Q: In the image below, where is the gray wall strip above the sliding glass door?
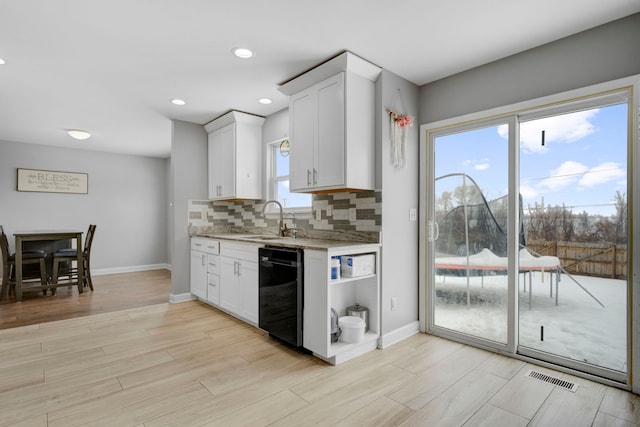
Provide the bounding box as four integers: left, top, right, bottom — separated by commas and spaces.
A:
420, 14, 640, 124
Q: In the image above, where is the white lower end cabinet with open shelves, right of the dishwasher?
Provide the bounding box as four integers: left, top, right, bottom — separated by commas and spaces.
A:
303, 245, 380, 364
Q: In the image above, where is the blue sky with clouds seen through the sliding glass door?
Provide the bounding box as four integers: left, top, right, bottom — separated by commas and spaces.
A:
435, 104, 627, 215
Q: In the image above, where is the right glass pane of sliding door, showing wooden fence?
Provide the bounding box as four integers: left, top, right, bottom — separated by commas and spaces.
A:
519, 103, 629, 380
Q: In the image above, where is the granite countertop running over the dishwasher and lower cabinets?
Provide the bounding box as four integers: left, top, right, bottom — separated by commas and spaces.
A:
194, 233, 380, 250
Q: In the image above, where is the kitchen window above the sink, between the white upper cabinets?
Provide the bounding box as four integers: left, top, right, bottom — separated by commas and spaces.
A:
267, 138, 311, 213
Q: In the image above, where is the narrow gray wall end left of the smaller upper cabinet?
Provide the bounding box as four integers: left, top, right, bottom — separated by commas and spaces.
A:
167, 120, 208, 301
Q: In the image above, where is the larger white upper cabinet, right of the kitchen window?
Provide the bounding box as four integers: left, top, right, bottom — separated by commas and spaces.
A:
280, 52, 380, 193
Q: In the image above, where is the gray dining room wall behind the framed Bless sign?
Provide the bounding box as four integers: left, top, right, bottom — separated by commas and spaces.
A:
0, 141, 167, 274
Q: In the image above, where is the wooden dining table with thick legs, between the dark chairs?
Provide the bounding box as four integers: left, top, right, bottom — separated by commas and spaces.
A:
13, 230, 84, 301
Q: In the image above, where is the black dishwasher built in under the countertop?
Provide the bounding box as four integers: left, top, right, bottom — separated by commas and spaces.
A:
258, 246, 303, 347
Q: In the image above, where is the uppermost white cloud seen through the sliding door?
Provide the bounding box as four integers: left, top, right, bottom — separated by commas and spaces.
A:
498, 109, 600, 153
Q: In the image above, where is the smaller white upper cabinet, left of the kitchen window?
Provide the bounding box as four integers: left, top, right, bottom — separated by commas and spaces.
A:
205, 111, 264, 200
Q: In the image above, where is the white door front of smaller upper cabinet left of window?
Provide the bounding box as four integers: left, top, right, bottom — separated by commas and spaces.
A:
208, 123, 235, 200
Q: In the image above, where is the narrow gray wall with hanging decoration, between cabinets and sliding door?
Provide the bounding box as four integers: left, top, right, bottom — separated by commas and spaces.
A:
376, 70, 420, 341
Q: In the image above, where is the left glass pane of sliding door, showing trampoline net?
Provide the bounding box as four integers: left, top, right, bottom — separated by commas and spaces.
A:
427, 123, 509, 345
